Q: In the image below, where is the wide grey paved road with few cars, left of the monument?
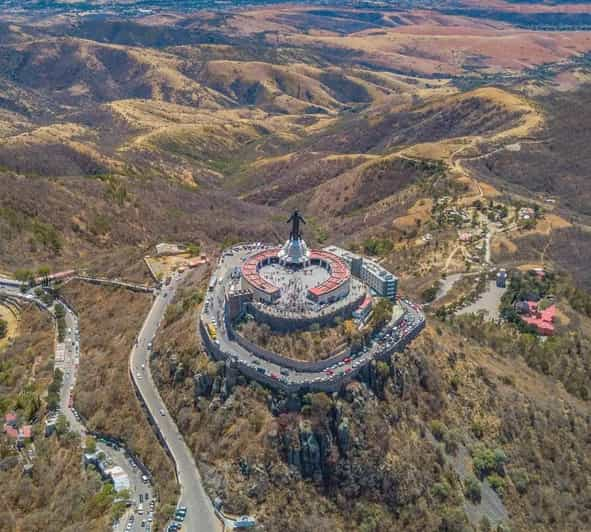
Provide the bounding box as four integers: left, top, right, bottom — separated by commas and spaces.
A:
130, 276, 221, 532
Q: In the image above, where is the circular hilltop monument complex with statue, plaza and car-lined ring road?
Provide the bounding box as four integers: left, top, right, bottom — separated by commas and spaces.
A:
200, 210, 425, 391
